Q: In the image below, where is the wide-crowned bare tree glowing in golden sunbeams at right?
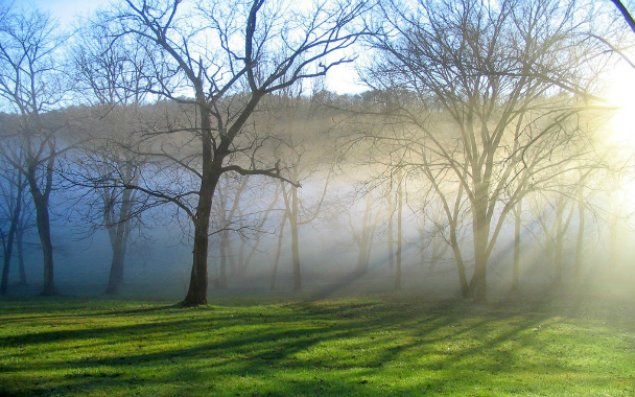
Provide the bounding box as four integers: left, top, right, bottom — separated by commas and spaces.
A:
370, 0, 600, 301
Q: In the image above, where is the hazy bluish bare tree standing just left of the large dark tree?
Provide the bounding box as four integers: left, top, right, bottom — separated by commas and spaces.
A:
71, 19, 152, 294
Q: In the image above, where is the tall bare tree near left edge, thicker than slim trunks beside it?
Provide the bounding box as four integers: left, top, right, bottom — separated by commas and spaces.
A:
0, 10, 65, 295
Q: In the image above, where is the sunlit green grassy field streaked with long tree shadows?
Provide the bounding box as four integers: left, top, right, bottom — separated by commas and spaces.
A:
0, 297, 635, 397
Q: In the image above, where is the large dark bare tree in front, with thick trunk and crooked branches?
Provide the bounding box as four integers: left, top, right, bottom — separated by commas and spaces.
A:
104, 0, 365, 305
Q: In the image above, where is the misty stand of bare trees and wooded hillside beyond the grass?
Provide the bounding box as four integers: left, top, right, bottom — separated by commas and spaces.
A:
0, 0, 635, 305
